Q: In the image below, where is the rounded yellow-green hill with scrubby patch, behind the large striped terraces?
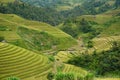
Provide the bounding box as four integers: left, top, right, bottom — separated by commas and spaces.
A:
0, 14, 76, 51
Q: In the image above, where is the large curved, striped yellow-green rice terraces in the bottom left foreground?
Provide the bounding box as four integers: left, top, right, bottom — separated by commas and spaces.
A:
0, 43, 52, 80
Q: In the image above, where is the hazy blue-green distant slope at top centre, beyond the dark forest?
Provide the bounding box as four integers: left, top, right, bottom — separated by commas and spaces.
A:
22, 0, 83, 10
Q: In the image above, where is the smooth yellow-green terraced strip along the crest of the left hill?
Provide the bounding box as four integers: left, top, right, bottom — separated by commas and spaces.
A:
0, 14, 70, 37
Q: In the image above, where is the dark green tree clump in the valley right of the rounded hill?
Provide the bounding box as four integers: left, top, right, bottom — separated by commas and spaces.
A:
60, 18, 100, 42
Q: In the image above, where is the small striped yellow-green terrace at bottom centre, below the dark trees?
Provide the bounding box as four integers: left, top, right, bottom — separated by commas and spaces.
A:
63, 64, 87, 76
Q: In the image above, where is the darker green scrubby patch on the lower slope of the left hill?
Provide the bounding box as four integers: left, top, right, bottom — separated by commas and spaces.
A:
18, 27, 76, 51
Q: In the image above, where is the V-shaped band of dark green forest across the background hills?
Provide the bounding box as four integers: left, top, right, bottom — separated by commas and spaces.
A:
0, 0, 120, 26
